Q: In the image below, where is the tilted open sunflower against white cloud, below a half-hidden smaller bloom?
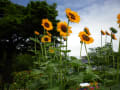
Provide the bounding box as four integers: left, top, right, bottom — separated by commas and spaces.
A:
78, 31, 94, 44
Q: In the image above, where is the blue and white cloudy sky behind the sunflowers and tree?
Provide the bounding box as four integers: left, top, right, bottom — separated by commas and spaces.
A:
11, 0, 120, 57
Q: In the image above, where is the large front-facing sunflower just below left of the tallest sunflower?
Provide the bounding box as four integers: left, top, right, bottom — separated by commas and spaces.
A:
57, 22, 72, 36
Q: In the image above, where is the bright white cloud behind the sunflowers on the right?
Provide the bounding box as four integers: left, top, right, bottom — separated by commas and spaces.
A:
61, 0, 120, 56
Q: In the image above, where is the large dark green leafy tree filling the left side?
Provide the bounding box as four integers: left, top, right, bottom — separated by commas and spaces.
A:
0, 0, 59, 84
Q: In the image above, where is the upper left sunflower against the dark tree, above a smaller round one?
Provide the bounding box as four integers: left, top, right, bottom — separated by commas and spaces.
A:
41, 19, 53, 31
